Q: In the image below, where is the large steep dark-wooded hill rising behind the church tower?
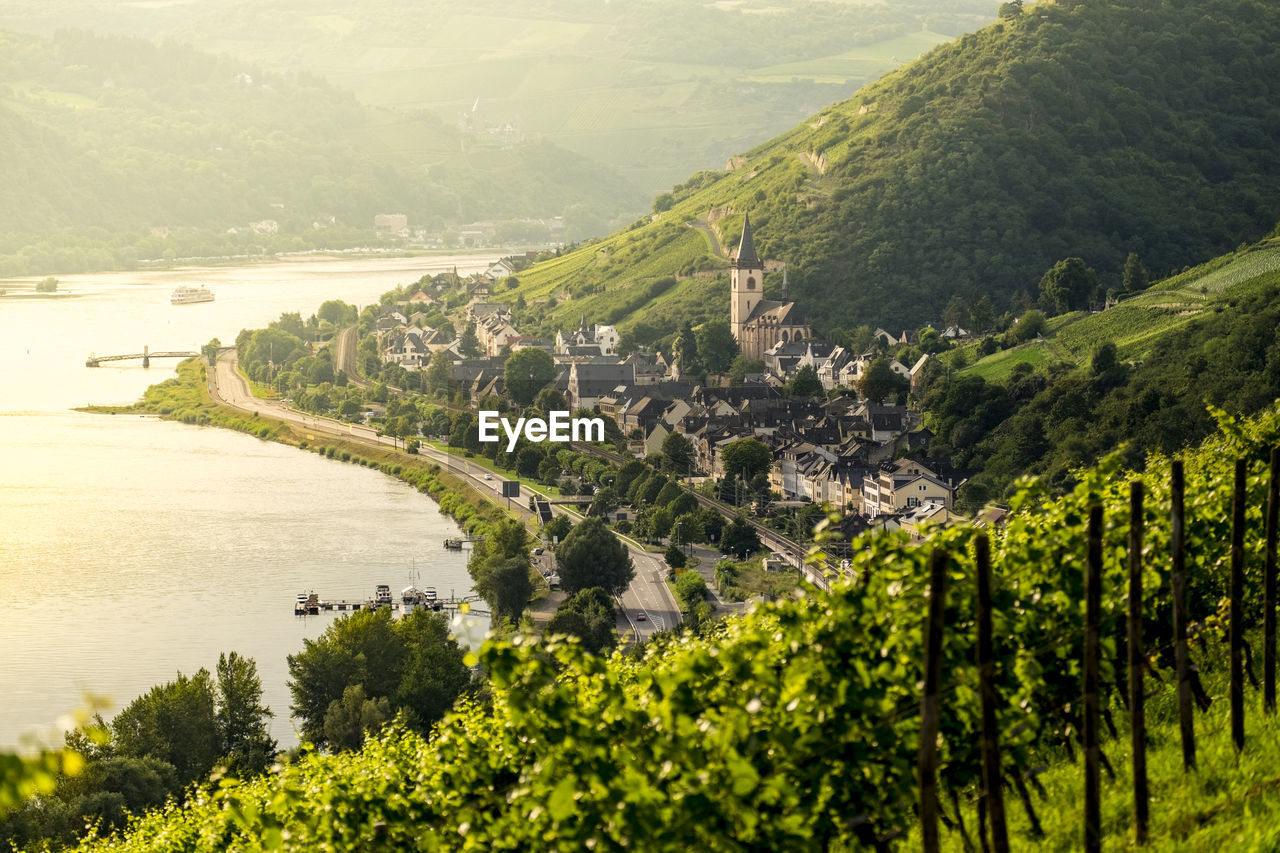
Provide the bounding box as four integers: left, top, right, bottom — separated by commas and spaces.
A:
499, 0, 1280, 333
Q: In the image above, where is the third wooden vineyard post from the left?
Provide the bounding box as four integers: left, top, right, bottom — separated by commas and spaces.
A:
1082, 506, 1102, 853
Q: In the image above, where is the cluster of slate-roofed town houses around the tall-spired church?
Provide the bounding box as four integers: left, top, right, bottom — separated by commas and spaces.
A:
370, 218, 983, 543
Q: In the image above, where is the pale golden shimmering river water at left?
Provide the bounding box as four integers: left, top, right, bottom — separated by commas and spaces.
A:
0, 255, 493, 747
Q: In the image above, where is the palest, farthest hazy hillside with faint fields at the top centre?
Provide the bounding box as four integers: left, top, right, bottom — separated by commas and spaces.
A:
0, 0, 996, 192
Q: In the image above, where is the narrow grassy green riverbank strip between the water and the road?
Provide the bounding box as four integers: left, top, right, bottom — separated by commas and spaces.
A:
77, 359, 507, 535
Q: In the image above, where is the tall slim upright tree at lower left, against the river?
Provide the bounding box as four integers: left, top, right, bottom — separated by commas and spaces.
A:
216, 652, 275, 779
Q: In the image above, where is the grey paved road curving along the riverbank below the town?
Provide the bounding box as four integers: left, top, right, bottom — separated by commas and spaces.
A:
209, 345, 680, 642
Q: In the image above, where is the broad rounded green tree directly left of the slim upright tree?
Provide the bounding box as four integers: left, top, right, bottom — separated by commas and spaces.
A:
111, 669, 223, 783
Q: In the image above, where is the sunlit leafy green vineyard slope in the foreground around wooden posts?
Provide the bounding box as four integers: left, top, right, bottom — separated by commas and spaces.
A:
45, 402, 1280, 853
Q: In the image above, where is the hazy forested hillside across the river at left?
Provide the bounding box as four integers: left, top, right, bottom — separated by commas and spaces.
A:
0, 31, 644, 274
